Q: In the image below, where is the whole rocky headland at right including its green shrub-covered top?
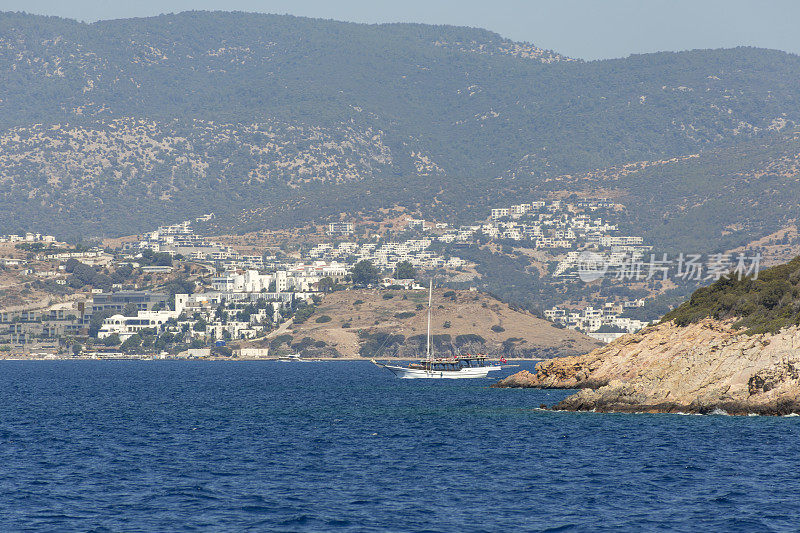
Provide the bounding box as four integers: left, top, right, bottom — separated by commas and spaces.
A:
493, 259, 800, 415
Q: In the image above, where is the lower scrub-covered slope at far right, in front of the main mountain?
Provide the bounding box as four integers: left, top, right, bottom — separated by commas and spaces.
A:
510, 132, 800, 252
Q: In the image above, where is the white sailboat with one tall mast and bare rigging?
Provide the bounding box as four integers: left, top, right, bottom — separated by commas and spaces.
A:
372, 279, 503, 379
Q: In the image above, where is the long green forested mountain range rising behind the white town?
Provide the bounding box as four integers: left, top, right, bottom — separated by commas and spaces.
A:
0, 12, 800, 248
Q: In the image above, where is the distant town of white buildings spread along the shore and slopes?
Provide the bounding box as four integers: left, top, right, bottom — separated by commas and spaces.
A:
0, 199, 650, 357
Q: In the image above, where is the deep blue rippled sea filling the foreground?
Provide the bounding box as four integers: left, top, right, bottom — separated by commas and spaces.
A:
0, 361, 800, 532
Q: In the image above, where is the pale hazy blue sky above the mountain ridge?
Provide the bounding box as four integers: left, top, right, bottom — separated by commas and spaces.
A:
6, 0, 800, 59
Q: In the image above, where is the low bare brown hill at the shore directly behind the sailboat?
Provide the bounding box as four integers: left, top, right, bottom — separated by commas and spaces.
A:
256, 289, 599, 359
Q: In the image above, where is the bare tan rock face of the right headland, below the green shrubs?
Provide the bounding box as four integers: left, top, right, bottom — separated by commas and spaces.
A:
494, 319, 800, 415
